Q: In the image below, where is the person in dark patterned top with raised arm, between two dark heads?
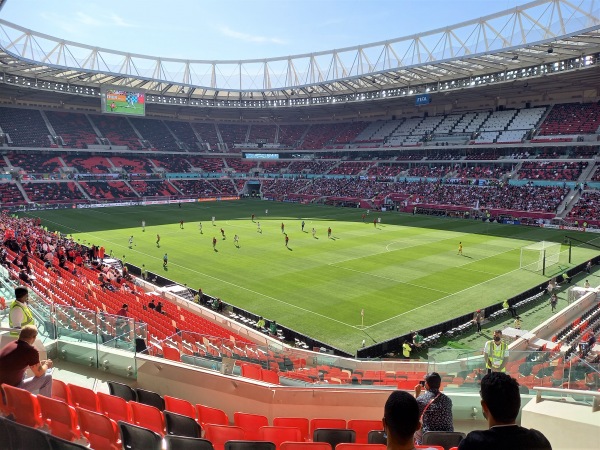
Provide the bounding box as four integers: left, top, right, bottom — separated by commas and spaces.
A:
415, 372, 454, 445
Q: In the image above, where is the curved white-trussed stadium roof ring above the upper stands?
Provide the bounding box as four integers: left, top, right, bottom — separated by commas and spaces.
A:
0, 0, 600, 115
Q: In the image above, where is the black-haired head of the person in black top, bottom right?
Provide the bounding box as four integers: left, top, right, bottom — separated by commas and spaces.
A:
480, 372, 521, 426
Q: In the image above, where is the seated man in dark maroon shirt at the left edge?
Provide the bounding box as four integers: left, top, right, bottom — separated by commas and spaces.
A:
0, 325, 53, 397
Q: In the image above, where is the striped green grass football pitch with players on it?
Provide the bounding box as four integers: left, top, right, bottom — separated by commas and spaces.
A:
21, 200, 600, 353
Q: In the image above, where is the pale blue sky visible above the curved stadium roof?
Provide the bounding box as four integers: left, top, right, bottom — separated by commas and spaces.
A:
0, 0, 527, 60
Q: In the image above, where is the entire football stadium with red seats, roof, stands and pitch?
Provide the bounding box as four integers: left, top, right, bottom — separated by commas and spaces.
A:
0, 0, 600, 450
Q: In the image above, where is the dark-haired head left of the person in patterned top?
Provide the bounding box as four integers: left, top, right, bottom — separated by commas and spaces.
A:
382, 391, 420, 444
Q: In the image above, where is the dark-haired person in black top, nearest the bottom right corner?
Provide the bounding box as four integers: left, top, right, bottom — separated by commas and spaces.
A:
458, 372, 552, 450
